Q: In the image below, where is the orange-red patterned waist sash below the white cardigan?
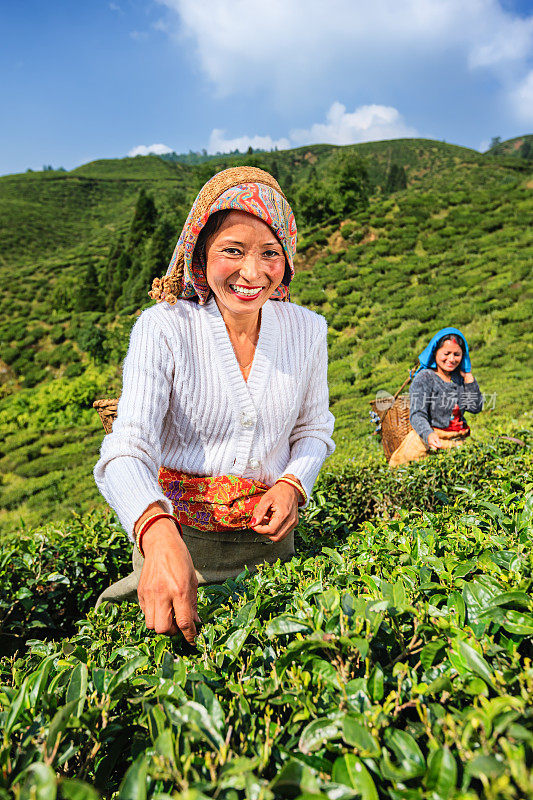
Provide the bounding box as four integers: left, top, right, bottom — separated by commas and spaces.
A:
159, 467, 269, 531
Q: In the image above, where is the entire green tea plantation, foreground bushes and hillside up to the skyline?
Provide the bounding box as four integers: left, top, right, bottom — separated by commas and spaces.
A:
0, 141, 533, 800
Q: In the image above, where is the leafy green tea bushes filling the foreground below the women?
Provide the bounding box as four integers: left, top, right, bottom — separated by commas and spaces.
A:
0, 440, 533, 800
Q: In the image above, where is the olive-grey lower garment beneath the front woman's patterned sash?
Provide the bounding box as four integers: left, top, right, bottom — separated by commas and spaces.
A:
96, 525, 294, 608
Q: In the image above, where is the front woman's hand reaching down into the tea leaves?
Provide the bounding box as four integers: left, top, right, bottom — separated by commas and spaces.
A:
137, 519, 202, 644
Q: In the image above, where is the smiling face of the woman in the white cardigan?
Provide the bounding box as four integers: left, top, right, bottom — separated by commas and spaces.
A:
206, 211, 285, 315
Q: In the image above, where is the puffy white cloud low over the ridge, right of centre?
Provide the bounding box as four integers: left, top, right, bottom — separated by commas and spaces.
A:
291, 102, 418, 146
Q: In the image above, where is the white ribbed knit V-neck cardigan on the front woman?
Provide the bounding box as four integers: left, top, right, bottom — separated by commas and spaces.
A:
94, 297, 335, 538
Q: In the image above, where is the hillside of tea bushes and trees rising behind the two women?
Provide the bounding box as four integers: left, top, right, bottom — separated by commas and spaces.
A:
0, 139, 533, 530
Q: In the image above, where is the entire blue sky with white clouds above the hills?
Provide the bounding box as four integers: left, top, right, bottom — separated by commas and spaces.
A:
0, 0, 533, 174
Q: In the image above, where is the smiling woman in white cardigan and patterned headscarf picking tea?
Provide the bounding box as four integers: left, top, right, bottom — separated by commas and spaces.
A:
91, 167, 334, 641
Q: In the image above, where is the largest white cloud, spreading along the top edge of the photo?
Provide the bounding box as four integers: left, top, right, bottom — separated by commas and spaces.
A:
159, 0, 533, 100
